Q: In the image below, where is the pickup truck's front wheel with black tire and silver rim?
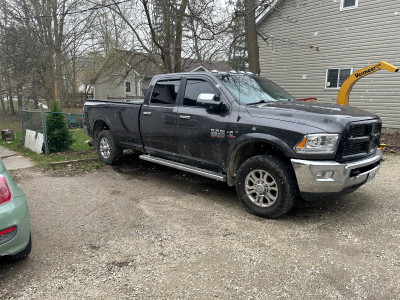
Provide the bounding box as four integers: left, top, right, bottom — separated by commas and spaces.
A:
236, 155, 299, 219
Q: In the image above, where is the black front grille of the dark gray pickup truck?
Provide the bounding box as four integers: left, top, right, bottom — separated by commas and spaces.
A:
338, 120, 382, 161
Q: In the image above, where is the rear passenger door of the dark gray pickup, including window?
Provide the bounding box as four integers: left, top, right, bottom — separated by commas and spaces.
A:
140, 78, 181, 158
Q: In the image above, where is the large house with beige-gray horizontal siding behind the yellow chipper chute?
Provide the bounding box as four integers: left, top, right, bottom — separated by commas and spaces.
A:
257, 0, 400, 128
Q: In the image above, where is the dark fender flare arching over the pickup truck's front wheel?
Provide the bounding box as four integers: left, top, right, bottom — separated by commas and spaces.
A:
227, 133, 295, 186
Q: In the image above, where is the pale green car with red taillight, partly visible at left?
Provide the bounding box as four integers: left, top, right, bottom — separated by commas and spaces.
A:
0, 160, 32, 260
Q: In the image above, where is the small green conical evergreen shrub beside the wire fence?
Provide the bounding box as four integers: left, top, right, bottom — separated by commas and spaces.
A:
46, 101, 74, 153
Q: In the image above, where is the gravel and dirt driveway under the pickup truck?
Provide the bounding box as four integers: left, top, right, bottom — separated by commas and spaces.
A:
0, 154, 400, 299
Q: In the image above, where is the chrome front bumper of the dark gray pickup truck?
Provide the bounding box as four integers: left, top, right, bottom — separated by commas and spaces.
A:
291, 149, 382, 194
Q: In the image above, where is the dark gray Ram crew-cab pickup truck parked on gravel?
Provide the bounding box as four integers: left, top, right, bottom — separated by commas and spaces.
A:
84, 72, 382, 218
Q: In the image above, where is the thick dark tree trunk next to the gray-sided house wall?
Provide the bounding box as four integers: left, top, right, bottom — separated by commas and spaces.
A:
244, 0, 260, 74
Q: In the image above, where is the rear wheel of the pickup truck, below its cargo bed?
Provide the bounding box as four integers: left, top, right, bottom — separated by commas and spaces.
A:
97, 130, 122, 165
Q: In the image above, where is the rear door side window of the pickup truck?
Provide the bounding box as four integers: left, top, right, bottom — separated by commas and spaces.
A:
150, 79, 181, 105
